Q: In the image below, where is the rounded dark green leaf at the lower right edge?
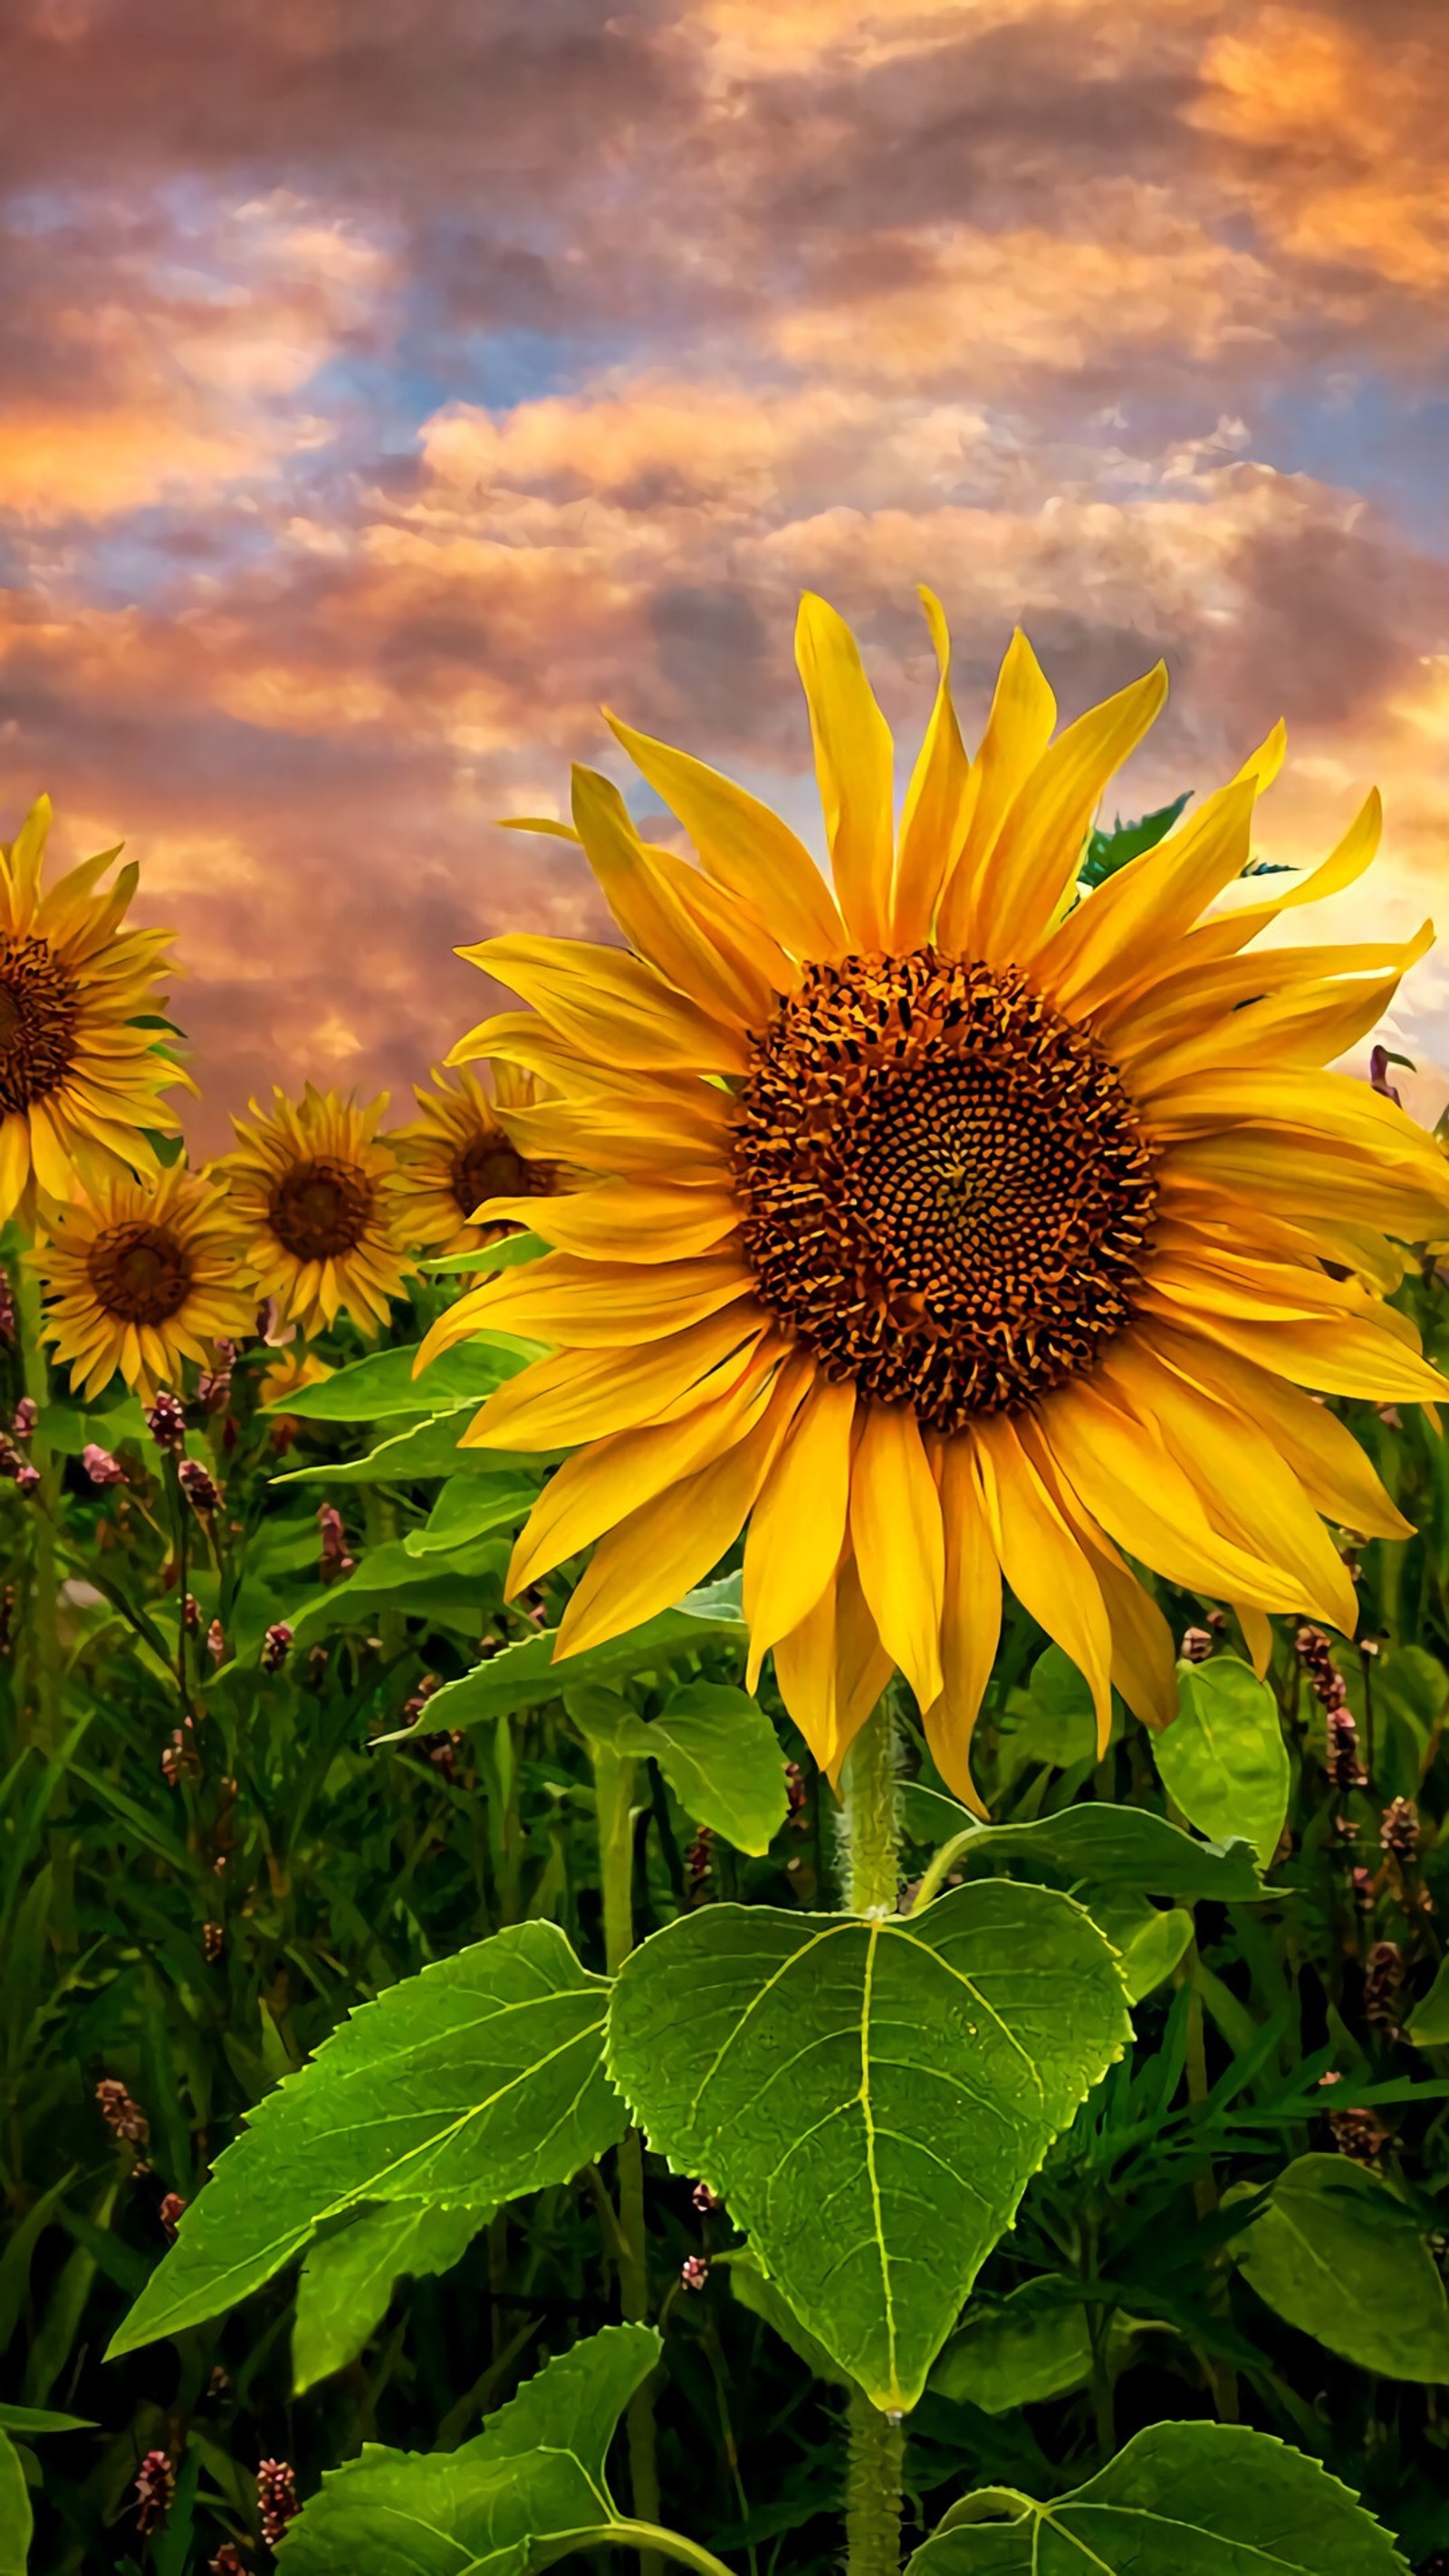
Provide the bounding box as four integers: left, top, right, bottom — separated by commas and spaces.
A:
1233, 2156, 1449, 2380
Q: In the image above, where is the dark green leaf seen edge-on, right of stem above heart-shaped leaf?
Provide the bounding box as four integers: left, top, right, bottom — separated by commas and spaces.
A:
904, 1788, 1266, 1904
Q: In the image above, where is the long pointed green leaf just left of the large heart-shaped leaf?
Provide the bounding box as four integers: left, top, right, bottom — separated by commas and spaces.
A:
110, 1922, 626, 2354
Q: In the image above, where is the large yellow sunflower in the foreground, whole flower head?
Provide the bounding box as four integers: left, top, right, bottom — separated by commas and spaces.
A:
419, 595, 1449, 1798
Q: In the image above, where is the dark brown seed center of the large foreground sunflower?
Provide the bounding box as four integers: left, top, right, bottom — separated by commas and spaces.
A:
734, 948, 1156, 1432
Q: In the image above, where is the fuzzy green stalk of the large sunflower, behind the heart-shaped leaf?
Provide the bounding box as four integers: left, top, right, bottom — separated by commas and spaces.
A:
841, 1700, 906, 2576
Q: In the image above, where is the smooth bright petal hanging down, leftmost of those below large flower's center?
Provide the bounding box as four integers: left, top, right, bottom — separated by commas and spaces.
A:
744, 1379, 855, 1690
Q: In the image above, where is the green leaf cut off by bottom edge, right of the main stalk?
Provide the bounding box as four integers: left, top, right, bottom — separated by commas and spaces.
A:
906, 2424, 1406, 2576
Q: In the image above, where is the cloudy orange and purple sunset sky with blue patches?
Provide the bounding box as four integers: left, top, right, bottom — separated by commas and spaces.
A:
0, 0, 1449, 1149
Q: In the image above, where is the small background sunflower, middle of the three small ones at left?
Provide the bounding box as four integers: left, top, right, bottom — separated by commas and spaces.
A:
216, 1081, 412, 1337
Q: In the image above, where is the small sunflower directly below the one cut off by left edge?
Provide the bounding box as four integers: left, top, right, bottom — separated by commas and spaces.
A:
31, 1164, 257, 1404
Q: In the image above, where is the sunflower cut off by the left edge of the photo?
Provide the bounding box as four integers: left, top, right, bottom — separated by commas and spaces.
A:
0, 796, 187, 1226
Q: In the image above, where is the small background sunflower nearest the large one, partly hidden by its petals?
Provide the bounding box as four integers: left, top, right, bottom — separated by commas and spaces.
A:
394, 1064, 561, 1252
